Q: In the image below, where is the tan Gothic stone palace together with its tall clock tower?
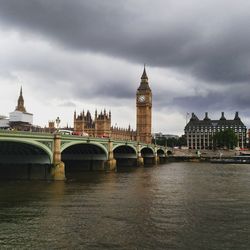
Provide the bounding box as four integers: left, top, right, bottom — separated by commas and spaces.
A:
74, 67, 152, 143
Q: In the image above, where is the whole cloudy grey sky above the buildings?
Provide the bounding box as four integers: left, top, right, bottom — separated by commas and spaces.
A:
0, 0, 250, 135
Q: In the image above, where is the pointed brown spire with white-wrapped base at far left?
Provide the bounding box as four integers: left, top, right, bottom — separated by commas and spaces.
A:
9, 87, 33, 130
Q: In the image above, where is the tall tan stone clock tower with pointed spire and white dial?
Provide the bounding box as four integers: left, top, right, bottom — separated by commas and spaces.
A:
136, 66, 152, 143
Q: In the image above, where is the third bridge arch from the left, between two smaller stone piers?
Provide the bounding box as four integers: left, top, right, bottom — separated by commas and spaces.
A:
113, 144, 137, 167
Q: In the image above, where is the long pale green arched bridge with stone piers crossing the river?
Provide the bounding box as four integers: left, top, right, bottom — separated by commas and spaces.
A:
0, 130, 170, 180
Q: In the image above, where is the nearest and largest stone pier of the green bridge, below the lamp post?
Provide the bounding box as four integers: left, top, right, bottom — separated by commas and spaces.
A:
50, 134, 65, 181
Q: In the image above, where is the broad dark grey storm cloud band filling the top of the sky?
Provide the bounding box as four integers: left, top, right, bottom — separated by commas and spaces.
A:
0, 0, 250, 84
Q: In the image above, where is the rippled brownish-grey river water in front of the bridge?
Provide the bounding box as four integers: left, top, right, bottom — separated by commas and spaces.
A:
0, 163, 250, 250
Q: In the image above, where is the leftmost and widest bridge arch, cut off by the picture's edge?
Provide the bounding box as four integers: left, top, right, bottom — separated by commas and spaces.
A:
0, 138, 53, 179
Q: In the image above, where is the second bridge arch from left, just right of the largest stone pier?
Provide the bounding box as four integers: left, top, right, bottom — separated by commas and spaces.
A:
61, 142, 108, 173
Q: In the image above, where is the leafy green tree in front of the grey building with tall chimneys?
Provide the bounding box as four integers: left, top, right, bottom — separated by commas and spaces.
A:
213, 129, 238, 149
